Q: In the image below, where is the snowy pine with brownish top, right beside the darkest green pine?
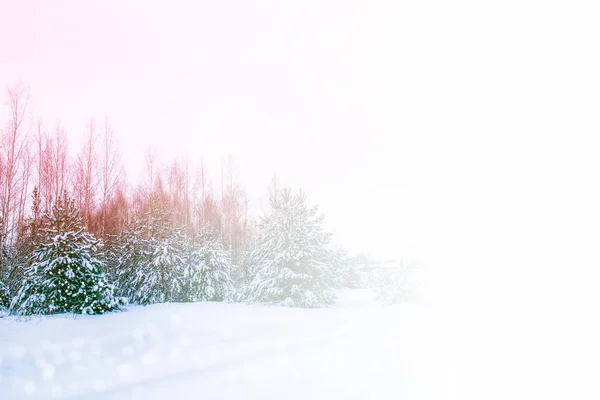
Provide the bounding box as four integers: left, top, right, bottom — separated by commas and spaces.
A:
114, 197, 185, 304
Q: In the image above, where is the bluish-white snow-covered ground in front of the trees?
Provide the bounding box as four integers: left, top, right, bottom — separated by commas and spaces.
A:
0, 290, 451, 400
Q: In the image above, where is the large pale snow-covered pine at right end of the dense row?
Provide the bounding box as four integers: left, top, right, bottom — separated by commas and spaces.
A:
245, 190, 335, 307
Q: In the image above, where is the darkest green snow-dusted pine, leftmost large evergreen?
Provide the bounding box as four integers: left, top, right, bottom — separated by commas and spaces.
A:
11, 193, 121, 315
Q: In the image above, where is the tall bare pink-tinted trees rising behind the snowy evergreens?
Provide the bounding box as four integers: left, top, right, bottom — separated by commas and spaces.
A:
0, 86, 253, 257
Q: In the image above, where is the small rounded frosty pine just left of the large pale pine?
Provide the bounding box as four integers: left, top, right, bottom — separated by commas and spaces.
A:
180, 229, 235, 301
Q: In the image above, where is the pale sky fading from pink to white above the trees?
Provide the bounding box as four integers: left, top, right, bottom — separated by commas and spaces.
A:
0, 0, 600, 306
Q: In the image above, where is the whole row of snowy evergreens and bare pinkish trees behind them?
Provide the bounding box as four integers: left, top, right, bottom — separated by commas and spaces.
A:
0, 86, 356, 313
